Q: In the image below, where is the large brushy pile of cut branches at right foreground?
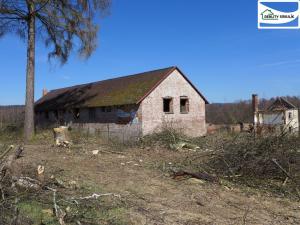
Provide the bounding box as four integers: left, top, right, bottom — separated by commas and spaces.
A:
207, 134, 300, 198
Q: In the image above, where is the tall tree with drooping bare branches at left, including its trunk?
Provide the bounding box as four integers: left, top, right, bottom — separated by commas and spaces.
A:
0, 0, 110, 141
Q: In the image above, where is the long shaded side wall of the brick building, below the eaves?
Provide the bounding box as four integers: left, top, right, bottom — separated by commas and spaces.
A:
36, 105, 142, 141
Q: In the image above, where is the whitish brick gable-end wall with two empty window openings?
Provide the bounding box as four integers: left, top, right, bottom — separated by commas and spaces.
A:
141, 71, 206, 137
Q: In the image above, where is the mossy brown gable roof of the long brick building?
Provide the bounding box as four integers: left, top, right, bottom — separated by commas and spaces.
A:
35, 67, 208, 111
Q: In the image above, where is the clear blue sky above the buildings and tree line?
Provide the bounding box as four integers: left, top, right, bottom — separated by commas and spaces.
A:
0, 0, 300, 105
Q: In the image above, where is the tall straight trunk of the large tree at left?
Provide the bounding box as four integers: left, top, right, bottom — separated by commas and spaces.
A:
24, 1, 35, 142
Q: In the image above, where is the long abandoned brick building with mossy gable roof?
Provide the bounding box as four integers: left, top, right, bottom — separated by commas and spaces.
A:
35, 67, 208, 139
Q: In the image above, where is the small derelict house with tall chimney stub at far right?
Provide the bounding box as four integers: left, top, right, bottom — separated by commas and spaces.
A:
253, 95, 299, 133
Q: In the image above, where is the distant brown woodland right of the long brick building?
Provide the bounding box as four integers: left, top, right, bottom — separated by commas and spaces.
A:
206, 96, 300, 124
